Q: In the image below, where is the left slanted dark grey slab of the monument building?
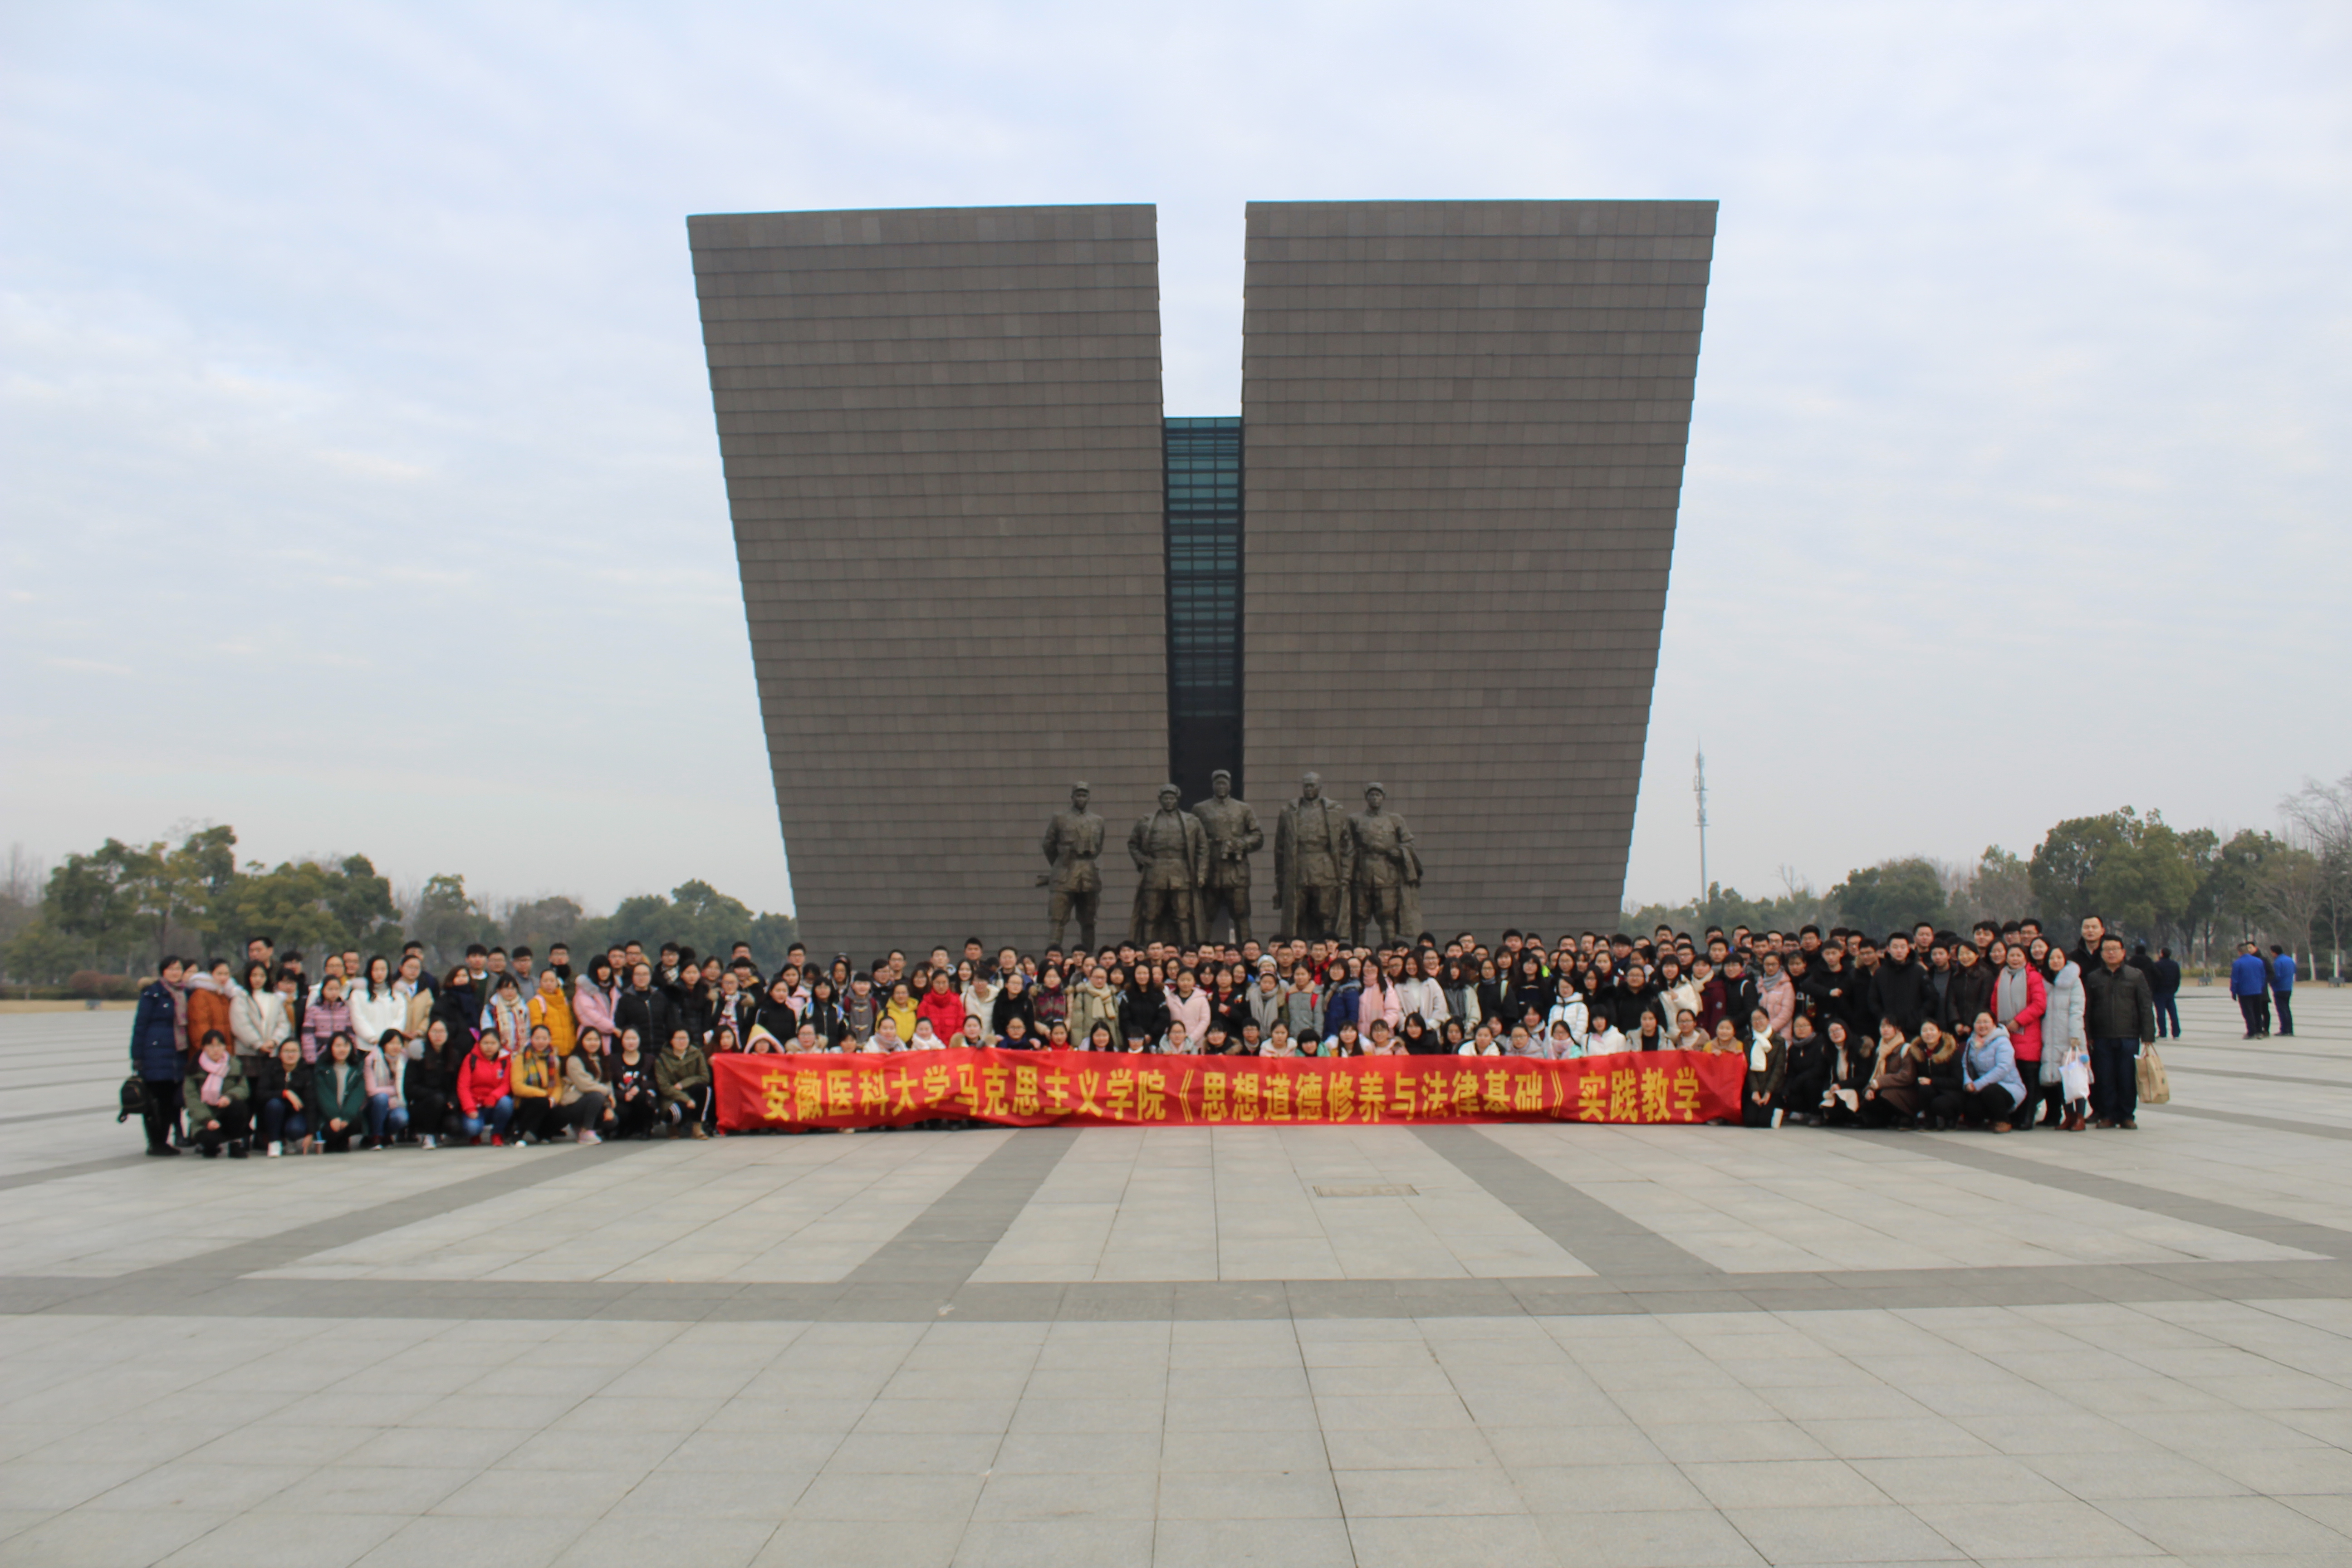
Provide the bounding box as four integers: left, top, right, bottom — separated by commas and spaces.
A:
682, 207, 1166, 966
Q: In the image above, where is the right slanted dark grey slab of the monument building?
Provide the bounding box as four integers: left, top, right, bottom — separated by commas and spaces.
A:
1242, 202, 1715, 941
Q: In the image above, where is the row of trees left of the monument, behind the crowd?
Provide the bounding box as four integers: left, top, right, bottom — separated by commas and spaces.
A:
0, 825, 800, 995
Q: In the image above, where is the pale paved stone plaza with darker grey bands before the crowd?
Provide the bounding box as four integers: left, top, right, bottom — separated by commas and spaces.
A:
0, 987, 2352, 1568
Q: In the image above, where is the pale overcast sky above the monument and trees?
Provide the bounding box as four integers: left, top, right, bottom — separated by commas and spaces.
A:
0, 0, 2352, 907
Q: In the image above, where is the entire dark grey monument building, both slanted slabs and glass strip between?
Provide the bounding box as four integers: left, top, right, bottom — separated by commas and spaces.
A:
689, 202, 1715, 961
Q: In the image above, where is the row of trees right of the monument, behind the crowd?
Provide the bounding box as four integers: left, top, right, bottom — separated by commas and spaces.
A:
1627, 774, 2352, 975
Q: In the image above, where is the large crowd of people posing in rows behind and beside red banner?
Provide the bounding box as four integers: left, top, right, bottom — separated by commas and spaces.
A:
125, 917, 2154, 1159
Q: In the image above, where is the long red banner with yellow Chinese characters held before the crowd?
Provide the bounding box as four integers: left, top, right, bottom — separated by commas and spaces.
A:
710, 1046, 1748, 1133
